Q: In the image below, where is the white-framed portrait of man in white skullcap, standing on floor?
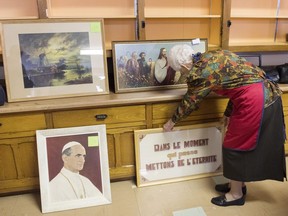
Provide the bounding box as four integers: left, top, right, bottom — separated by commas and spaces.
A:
36, 125, 112, 213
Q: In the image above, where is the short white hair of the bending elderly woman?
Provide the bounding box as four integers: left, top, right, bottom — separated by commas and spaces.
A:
168, 44, 195, 71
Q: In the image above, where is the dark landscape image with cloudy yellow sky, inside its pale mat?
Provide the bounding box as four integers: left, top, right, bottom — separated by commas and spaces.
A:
19, 32, 93, 88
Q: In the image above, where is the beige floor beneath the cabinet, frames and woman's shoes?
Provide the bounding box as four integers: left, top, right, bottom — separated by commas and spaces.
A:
0, 167, 288, 216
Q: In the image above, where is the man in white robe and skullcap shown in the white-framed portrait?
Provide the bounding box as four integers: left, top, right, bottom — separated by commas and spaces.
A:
49, 141, 102, 202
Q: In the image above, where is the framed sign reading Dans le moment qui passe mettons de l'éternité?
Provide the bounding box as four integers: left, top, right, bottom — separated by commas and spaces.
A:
134, 122, 223, 187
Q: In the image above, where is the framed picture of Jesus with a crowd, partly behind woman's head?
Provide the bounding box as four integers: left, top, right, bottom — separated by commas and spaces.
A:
112, 38, 208, 93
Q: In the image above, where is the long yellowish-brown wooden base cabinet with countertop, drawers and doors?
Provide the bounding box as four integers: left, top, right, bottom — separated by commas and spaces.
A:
0, 87, 288, 194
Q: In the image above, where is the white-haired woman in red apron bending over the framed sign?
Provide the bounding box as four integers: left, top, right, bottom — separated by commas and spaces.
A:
163, 45, 286, 206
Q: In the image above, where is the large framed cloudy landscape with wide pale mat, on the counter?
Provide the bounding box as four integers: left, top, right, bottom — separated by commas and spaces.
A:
1, 19, 109, 102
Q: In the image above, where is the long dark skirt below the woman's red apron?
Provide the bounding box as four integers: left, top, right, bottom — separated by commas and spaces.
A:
222, 98, 286, 182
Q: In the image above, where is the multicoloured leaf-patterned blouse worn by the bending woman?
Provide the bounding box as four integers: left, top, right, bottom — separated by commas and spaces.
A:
172, 50, 282, 123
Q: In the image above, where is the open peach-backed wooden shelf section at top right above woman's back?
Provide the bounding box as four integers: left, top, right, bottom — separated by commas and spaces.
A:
223, 0, 288, 51
